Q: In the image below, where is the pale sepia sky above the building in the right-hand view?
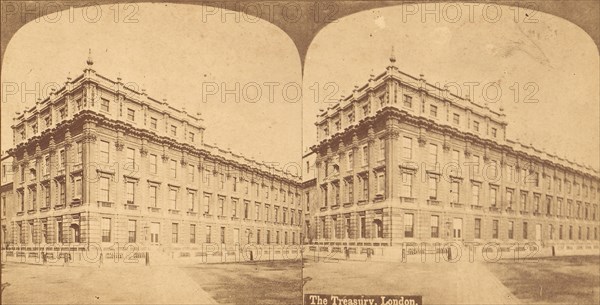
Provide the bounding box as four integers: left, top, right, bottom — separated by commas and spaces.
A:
303, 4, 600, 169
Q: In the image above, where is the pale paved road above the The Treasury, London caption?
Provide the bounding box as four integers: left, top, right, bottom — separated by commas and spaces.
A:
303, 261, 519, 304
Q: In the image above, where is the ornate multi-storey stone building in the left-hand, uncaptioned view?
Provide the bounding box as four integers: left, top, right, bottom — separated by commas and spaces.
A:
2, 58, 304, 249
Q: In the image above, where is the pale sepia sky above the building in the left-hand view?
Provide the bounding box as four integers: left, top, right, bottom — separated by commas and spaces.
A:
2, 4, 301, 166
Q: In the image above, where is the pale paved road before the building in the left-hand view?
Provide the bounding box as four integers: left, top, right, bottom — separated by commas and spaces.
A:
2, 263, 217, 304
